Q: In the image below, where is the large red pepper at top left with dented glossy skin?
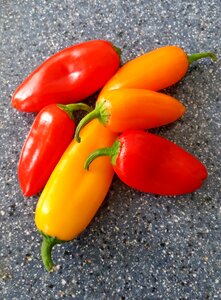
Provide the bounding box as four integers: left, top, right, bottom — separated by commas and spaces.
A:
12, 40, 121, 112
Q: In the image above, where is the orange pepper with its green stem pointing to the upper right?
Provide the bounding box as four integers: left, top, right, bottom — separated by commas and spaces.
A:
101, 46, 216, 95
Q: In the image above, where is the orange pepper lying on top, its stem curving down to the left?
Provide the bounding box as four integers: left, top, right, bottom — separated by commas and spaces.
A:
75, 89, 185, 141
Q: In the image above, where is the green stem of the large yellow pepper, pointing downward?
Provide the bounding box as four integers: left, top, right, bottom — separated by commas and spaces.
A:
41, 232, 64, 272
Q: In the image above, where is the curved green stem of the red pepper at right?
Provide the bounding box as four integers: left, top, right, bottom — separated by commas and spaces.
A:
84, 139, 120, 170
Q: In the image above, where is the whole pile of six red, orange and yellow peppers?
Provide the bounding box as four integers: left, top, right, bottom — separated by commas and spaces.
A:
12, 40, 216, 271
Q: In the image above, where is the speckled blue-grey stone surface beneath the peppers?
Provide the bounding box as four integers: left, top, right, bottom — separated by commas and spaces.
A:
0, 0, 221, 300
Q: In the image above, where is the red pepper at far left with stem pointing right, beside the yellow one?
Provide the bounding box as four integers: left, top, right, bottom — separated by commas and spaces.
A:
18, 103, 91, 196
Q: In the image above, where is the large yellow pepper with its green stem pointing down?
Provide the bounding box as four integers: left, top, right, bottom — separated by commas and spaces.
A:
35, 120, 117, 271
